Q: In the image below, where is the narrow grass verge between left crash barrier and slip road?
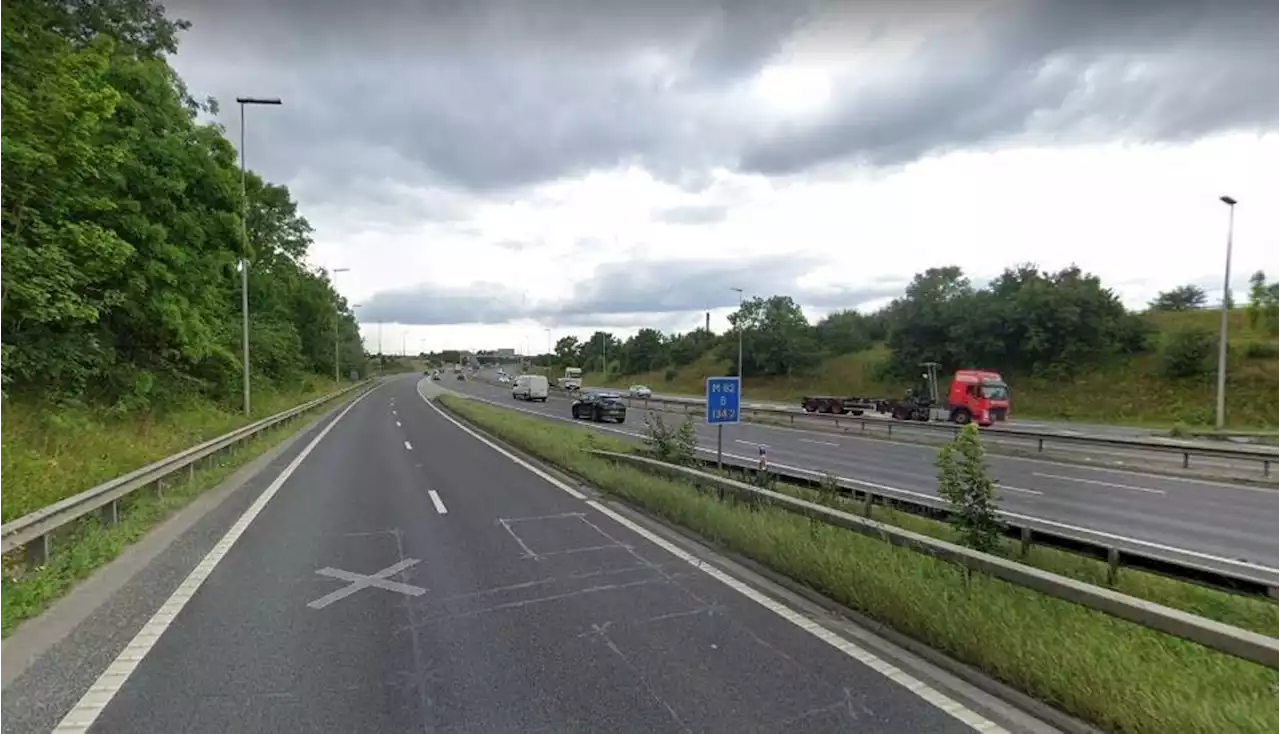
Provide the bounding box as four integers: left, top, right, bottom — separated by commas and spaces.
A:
0, 389, 360, 639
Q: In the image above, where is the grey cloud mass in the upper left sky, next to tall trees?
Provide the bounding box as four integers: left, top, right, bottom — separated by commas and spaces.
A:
170, 0, 815, 192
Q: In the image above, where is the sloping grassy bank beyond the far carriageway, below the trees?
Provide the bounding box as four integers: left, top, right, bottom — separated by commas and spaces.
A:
584, 309, 1280, 429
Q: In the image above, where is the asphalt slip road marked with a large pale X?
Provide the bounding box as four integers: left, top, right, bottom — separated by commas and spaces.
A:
0, 375, 1046, 734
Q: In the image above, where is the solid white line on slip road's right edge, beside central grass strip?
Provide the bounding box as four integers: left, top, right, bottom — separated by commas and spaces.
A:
419, 381, 1009, 734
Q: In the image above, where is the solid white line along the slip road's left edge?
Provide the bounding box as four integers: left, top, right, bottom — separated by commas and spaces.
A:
52, 386, 381, 733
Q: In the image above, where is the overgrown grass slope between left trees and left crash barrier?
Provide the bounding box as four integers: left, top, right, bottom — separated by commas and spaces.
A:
0, 377, 339, 523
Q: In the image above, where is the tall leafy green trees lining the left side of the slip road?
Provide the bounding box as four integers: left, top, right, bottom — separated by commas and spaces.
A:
0, 0, 365, 410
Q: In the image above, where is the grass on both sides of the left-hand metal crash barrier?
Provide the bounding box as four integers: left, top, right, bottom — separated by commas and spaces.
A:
0, 378, 353, 638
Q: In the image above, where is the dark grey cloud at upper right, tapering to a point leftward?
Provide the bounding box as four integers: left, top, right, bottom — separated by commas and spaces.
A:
740, 0, 1280, 174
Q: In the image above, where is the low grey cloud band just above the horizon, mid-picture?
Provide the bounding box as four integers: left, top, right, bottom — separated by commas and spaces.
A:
360, 256, 906, 327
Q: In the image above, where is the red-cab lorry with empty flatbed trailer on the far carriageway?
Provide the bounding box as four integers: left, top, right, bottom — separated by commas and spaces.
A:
800, 363, 1010, 427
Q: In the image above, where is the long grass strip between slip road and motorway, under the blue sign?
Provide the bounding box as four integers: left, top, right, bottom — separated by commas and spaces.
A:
442, 397, 1280, 734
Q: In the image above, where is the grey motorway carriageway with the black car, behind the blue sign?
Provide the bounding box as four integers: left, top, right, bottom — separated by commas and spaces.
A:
448, 375, 1280, 569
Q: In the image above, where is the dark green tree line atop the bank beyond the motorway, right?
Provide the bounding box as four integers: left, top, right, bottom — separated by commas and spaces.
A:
463, 264, 1280, 382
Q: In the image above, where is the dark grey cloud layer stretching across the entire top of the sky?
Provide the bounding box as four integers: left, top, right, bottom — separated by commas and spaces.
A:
169, 0, 1280, 201
